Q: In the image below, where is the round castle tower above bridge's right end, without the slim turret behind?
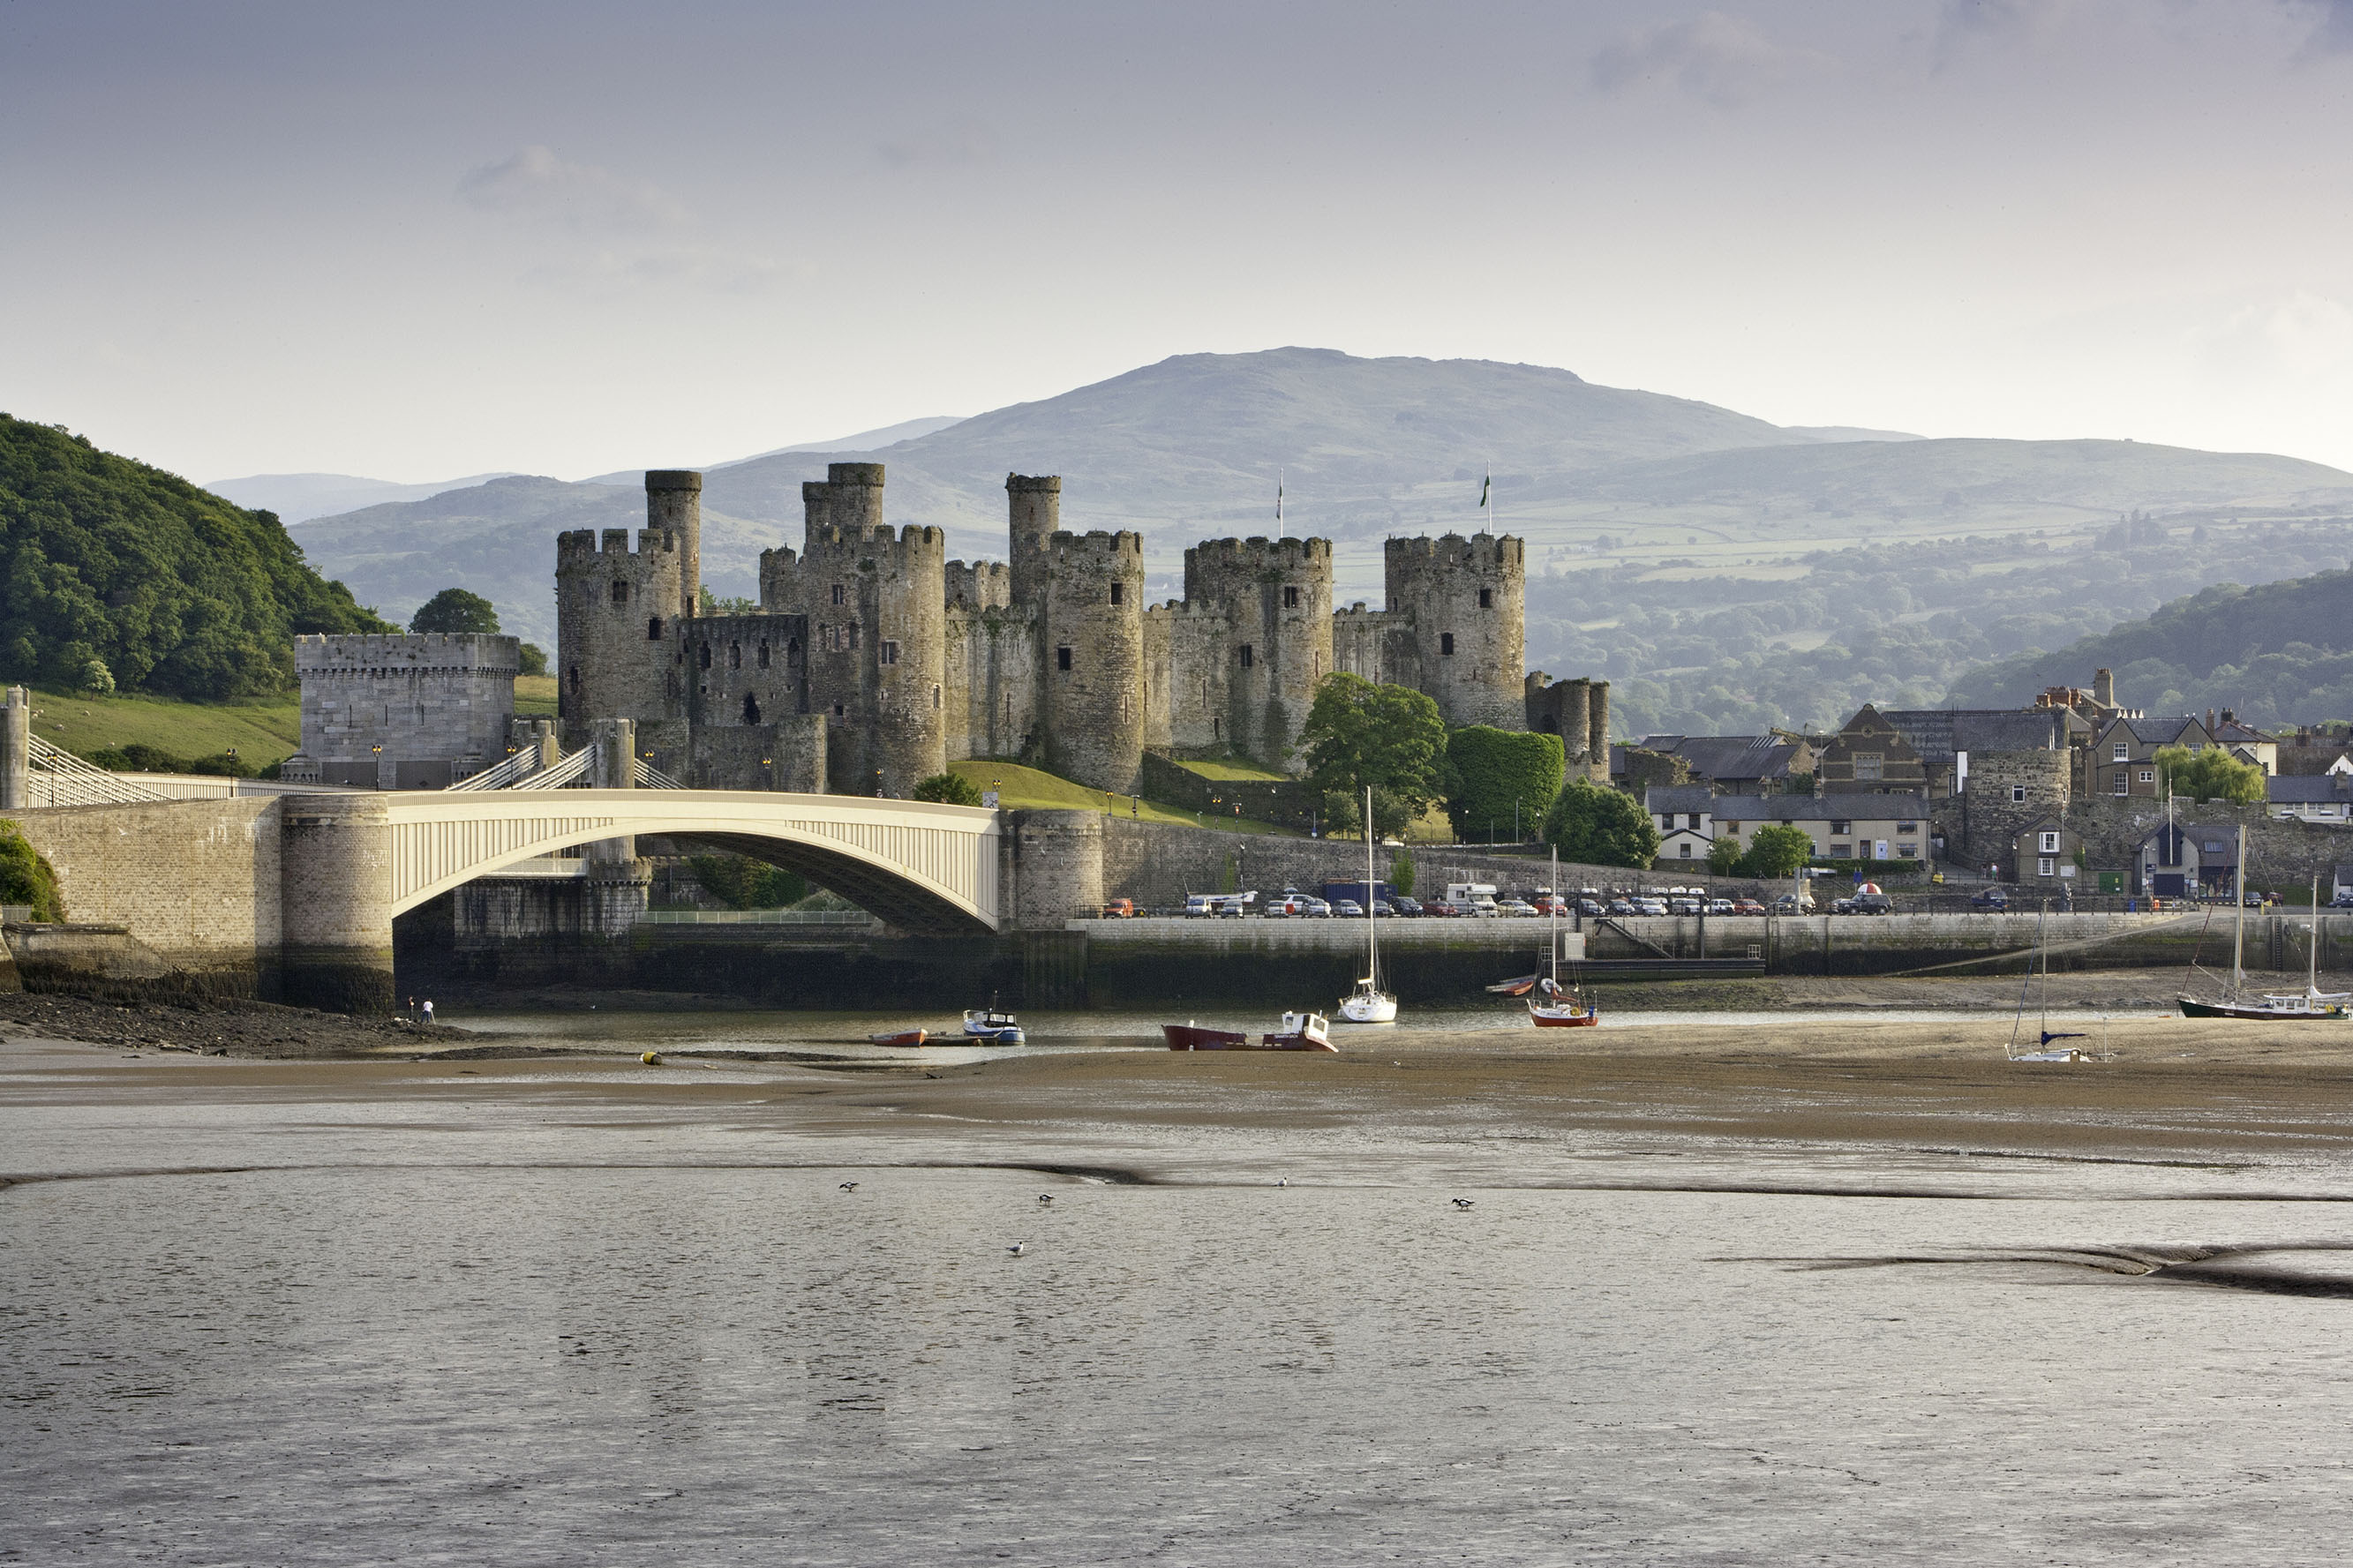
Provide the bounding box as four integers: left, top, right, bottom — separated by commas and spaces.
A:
1044, 534, 1144, 794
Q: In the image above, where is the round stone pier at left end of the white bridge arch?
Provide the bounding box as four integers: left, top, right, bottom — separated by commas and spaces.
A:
278, 794, 395, 1013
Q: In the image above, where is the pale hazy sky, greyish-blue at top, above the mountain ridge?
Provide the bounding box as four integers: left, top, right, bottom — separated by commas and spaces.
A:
0, 0, 2353, 479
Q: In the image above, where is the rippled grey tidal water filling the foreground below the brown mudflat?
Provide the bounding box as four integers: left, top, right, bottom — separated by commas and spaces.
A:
0, 1041, 2353, 1564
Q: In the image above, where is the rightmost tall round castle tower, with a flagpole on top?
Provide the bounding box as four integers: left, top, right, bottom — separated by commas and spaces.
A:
1384, 534, 1527, 729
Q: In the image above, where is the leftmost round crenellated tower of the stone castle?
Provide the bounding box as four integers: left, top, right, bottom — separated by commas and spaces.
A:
555, 514, 692, 746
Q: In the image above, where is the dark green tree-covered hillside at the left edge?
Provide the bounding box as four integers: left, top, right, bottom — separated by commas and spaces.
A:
0, 414, 395, 701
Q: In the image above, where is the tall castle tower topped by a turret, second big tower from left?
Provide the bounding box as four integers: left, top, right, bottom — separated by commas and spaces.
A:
790, 463, 948, 799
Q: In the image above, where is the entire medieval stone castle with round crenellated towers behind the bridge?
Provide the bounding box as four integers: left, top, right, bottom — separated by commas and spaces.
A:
555, 463, 1610, 797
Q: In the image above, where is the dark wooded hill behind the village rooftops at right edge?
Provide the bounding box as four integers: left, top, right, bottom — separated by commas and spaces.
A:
1953, 557, 2353, 726
